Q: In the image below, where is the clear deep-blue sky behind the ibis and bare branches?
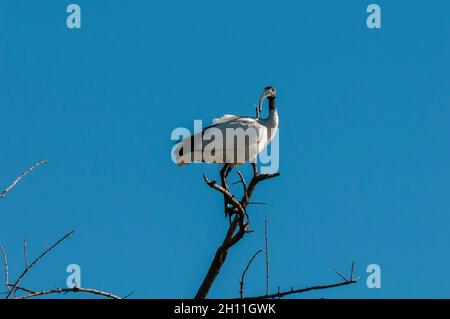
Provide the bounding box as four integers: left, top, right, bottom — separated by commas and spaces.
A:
0, 0, 450, 298
